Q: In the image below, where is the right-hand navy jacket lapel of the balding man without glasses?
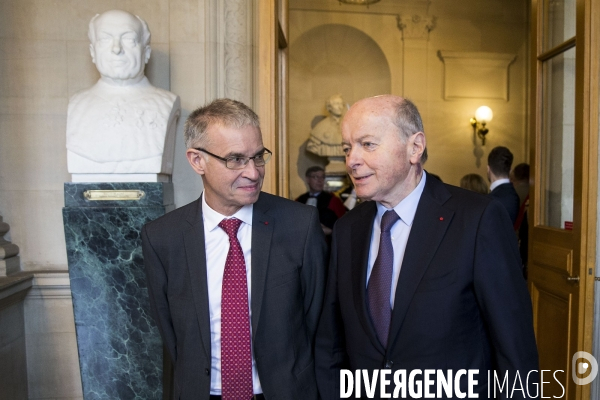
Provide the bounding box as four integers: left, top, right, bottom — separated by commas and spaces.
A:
388, 177, 454, 348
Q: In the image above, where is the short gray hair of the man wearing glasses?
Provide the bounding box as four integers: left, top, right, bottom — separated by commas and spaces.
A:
183, 99, 260, 149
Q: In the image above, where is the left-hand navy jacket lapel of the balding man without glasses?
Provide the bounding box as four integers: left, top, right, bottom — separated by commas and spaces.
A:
350, 202, 385, 354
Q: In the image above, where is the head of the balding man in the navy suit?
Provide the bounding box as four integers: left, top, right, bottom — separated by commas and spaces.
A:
342, 95, 427, 209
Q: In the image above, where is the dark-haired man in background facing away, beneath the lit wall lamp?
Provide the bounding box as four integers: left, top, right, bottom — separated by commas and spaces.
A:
488, 146, 521, 225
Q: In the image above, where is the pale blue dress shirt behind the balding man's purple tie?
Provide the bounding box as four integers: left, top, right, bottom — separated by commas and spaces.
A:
367, 172, 427, 309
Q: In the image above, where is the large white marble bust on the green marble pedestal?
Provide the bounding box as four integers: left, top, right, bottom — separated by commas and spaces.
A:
67, 10, 181, 182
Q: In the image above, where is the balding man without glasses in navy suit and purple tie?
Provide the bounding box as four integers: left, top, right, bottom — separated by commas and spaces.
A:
315, 95, 538, 400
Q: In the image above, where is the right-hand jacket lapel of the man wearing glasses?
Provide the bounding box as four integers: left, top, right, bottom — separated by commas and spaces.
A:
250, 194, 276, 337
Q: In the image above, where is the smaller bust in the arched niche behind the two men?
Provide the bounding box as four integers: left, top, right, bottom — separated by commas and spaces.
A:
306, 94, 345, 157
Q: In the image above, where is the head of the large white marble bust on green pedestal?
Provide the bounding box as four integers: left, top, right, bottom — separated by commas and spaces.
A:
88, 10, 150, 86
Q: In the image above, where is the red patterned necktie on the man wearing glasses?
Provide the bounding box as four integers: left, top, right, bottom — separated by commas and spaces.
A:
219, 218, 254, 400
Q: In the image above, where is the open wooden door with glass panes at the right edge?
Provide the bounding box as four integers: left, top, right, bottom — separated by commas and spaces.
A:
528, 0, 598, 399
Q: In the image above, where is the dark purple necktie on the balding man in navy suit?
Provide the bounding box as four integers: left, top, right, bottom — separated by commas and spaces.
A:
367, 210, 400, 348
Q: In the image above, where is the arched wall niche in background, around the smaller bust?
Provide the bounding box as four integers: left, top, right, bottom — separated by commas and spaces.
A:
288, 24, 392, 197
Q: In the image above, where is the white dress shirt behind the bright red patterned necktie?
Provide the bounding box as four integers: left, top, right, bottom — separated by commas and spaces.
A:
202, 195, 262, 396
